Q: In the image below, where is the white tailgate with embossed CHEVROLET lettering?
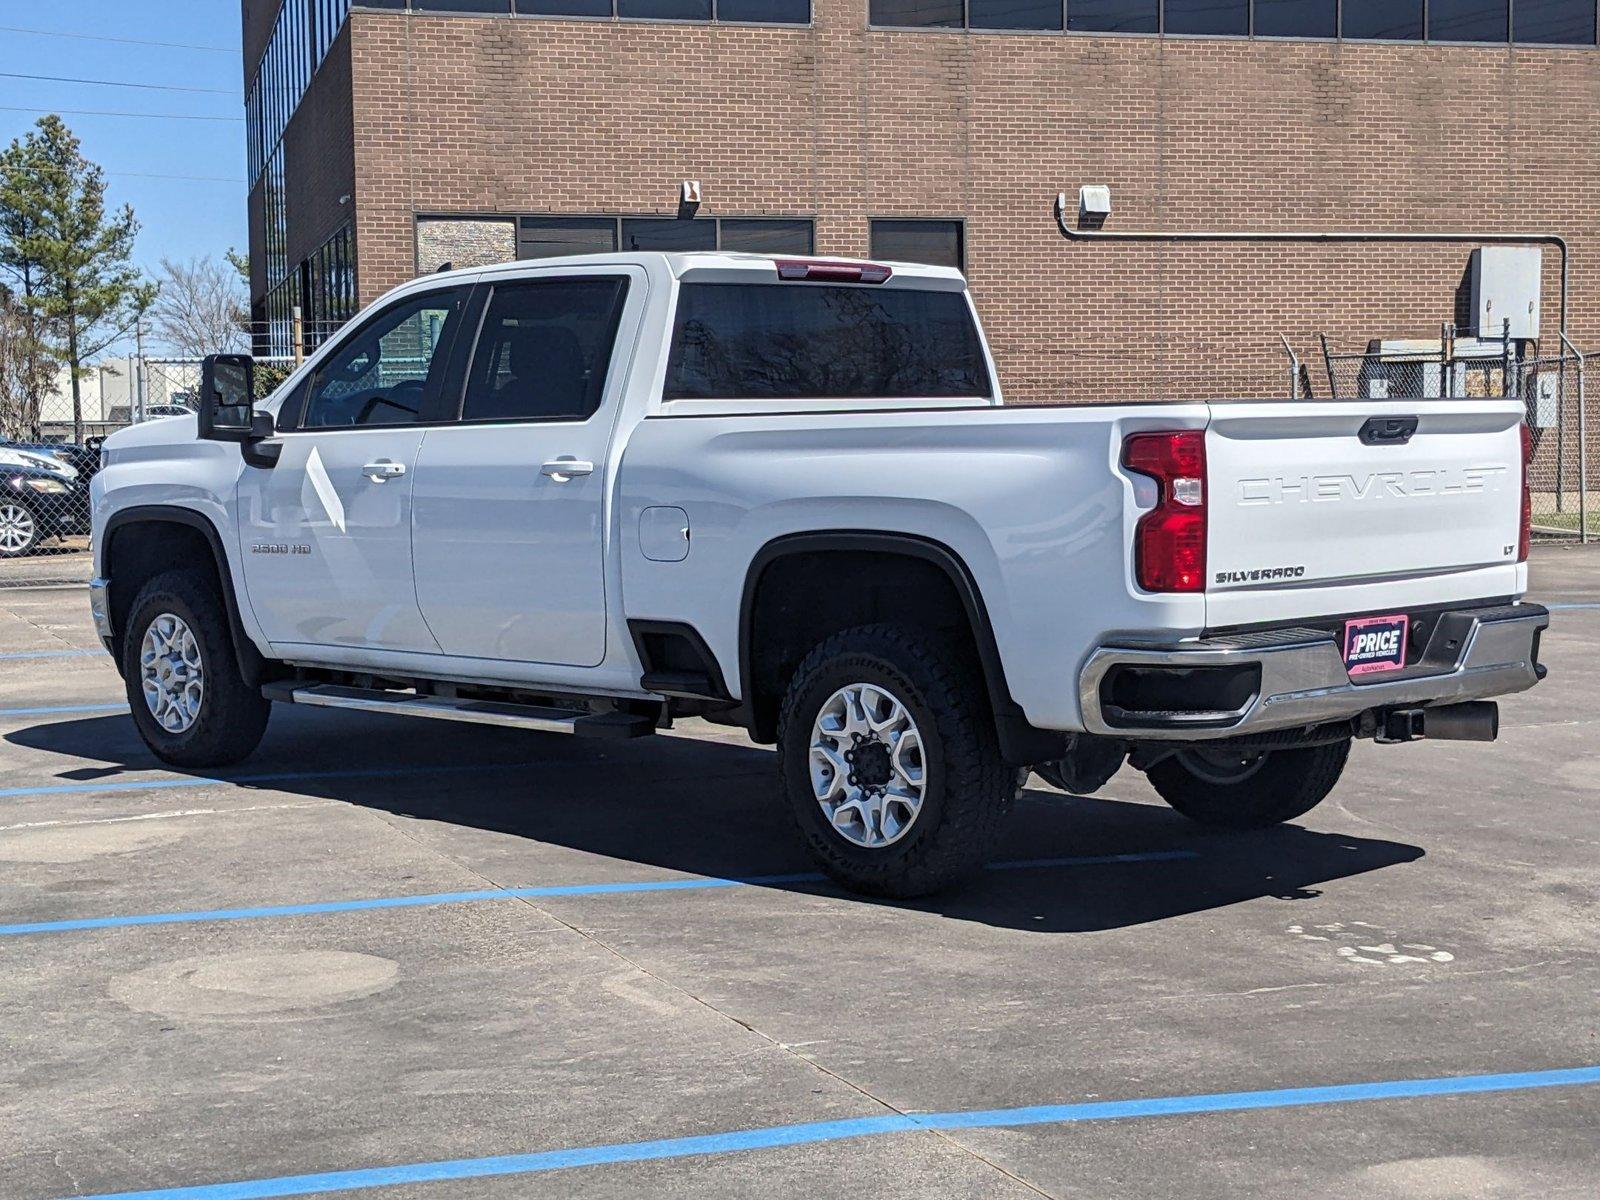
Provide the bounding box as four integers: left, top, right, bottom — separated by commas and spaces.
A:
1206, 400, 1523, 604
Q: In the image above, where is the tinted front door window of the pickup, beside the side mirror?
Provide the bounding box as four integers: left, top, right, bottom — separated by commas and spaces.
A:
301, 288, 466, 429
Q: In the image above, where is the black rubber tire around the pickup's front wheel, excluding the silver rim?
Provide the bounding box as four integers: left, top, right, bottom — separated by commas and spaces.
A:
122, 570, 272, 766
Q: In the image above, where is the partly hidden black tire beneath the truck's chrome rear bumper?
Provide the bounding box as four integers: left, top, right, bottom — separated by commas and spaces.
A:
1146, 738, 1350, 829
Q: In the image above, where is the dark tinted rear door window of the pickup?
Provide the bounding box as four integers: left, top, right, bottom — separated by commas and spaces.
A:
461, 275, 627, 421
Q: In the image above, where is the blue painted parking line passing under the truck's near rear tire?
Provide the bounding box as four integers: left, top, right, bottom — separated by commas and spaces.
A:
0, 850, 1200, 938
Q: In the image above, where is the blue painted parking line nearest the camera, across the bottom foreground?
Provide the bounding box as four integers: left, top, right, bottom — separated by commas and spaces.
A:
56, 1067, 1600, 1200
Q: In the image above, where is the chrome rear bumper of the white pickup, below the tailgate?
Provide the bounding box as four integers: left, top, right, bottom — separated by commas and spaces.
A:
1080, 603, 1550, 741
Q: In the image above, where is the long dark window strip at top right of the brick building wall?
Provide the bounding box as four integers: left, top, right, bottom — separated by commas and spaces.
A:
867, 0, 1597, 38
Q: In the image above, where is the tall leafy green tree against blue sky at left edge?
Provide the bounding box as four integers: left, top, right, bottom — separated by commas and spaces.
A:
0, 114, 157, 442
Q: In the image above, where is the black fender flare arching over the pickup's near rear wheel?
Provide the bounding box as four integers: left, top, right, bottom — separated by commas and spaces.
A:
738, 530, 1067, 766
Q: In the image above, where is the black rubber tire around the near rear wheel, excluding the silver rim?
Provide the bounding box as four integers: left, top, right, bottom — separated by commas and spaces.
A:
778, 626, 1018, 899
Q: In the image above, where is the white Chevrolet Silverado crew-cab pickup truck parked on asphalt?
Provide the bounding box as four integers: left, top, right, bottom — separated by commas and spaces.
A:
91, 253, 1549, 896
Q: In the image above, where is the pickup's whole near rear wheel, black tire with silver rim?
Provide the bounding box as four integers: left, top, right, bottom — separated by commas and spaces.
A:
778, 626, 1016, 898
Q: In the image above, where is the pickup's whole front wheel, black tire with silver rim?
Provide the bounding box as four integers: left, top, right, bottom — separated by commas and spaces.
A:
122, 571, 272, 766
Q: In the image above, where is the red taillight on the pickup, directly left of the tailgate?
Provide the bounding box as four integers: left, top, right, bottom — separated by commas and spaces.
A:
1122, 429, 1205, 592
